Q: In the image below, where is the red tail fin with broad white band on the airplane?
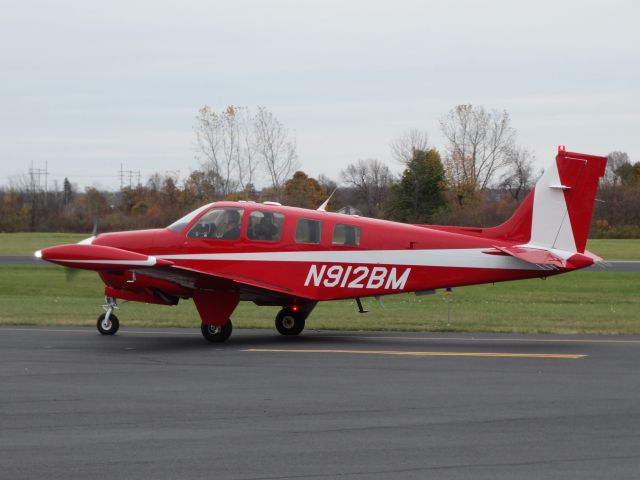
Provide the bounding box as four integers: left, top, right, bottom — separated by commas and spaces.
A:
483, 146, 607, 253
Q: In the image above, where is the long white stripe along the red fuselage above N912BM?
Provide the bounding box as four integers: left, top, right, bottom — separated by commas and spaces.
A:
155, 248, 568, 270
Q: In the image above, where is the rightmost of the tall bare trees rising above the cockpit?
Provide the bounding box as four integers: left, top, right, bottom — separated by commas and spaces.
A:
253, 107, 298, 199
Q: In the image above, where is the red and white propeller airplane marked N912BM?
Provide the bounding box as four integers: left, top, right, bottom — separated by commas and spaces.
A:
35, 147, 607, 342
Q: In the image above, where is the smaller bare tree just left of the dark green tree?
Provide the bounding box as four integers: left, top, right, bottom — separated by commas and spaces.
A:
340, 158, 393, 217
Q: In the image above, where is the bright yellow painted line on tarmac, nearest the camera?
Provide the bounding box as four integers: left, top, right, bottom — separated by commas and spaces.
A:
242, 348, 587, 359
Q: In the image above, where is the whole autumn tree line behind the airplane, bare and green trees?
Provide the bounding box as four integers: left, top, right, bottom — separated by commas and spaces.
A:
0, 105, 640, 237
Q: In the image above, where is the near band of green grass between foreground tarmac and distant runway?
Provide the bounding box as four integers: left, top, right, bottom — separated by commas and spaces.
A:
0, 266, 640, 334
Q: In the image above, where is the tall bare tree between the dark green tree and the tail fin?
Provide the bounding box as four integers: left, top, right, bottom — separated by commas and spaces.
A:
440, 105, 515, 203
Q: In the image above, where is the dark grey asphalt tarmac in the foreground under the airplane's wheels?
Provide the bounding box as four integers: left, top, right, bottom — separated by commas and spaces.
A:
0, 327, 640, 480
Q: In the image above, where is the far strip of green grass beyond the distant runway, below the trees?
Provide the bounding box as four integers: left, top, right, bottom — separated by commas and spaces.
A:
0, 233, 640, 260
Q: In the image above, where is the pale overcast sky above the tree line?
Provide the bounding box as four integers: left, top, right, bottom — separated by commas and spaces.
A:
0, 0, 640, 188
